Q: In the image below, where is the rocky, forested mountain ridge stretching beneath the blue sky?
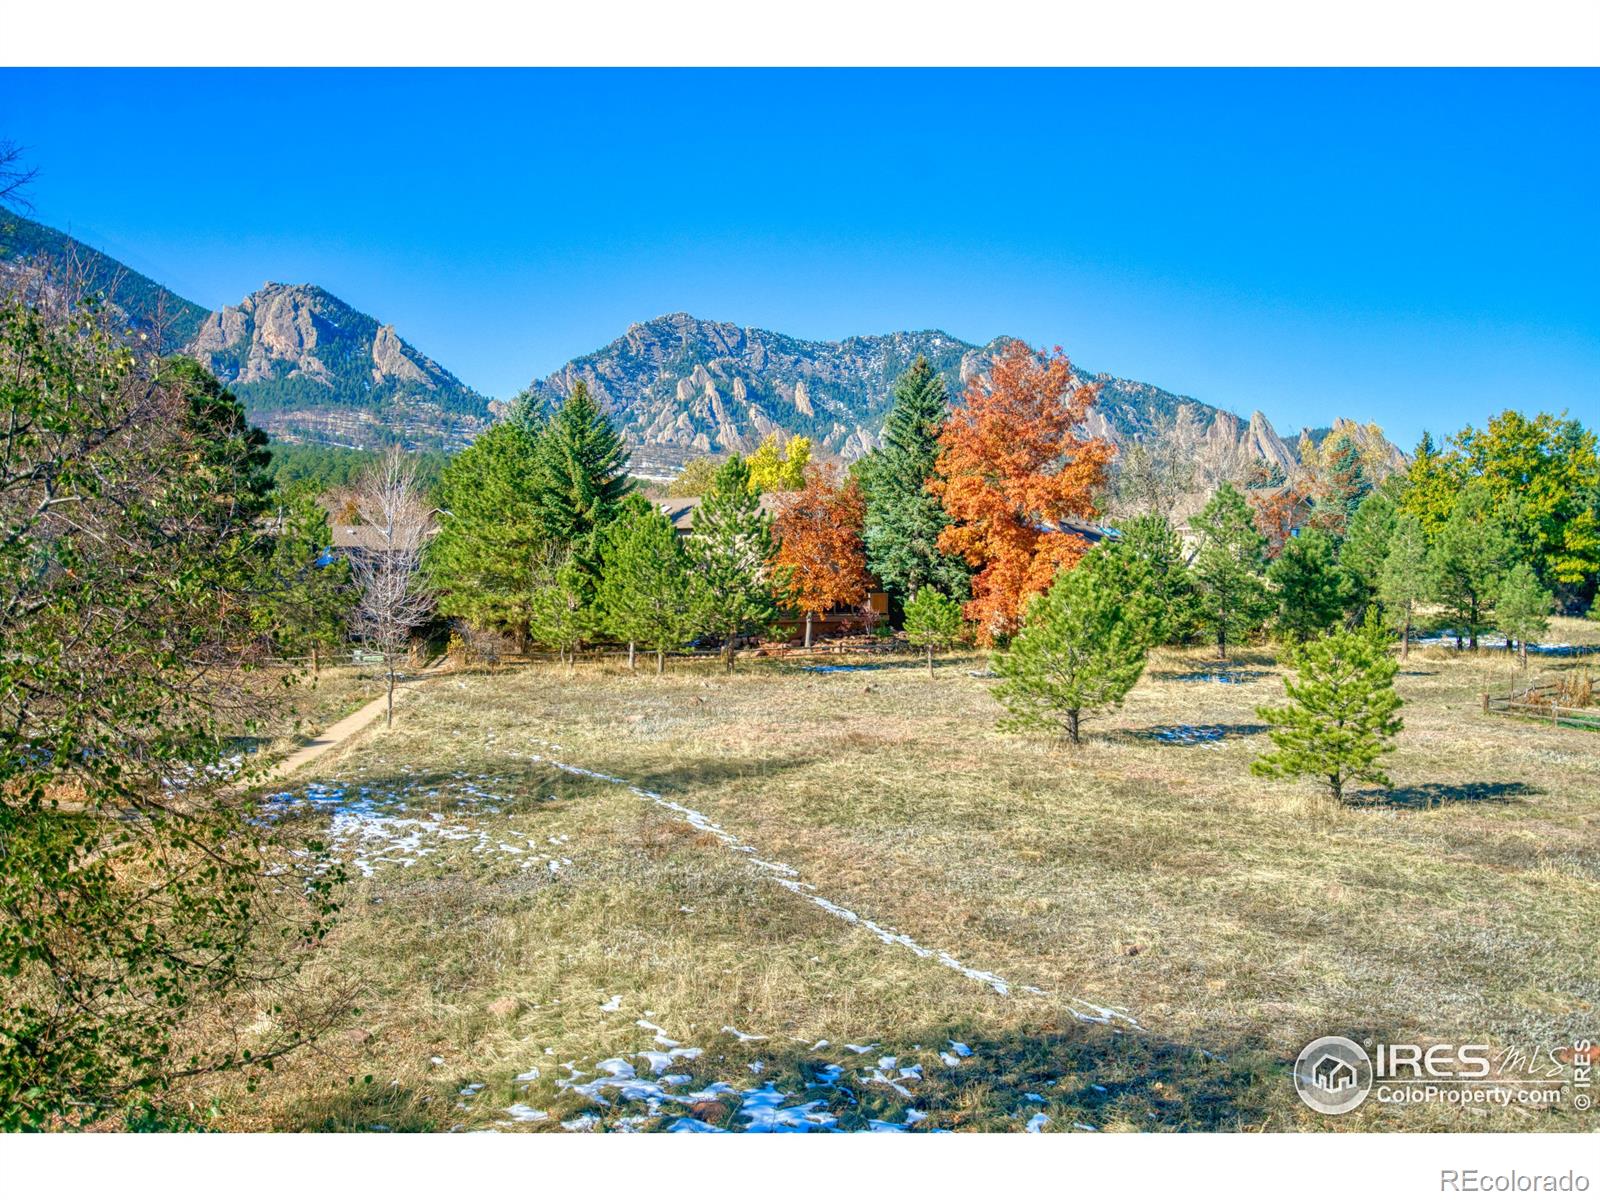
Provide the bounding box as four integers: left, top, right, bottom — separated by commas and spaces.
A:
0, 211, 1398, 478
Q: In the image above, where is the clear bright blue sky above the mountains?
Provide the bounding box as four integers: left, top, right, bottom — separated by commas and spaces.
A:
0, 70, 1600, 446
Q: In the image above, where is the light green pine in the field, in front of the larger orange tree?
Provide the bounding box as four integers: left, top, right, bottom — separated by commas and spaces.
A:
994, 550, 1149, 744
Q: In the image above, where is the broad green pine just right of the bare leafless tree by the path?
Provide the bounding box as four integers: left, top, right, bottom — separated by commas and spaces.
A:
426, 421, 550, 640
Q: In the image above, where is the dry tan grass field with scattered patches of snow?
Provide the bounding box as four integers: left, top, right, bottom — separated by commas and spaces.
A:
195, 621, 1600, 1131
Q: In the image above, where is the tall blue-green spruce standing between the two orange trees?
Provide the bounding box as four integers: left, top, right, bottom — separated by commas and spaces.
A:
861, 357, 971, 600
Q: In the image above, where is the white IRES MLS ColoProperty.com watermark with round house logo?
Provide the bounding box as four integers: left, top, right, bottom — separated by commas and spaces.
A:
1294, 1037, 1595, 1117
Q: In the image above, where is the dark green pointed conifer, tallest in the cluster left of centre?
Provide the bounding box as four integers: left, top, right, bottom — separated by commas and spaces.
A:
538, 379, 632, 572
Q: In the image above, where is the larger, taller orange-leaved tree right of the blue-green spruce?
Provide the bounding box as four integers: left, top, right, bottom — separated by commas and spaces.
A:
928, 342, 1112, 645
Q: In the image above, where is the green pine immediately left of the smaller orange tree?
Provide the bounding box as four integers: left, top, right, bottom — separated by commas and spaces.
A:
688, 454, 778, 670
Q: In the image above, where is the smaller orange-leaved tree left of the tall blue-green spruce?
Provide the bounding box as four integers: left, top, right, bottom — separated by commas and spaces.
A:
773, 466, 872, 646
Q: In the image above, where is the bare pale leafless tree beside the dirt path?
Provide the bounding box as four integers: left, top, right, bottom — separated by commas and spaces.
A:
350, 446, 434, 726
